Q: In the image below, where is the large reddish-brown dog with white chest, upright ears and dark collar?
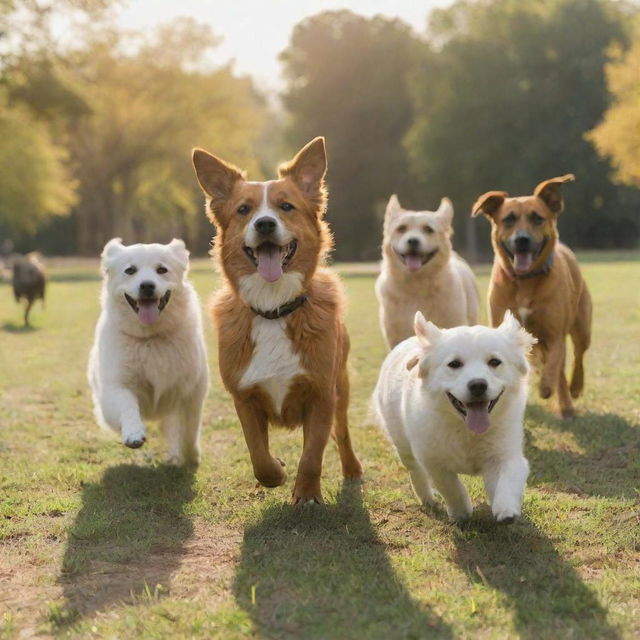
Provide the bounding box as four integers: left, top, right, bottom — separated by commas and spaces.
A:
193, 138, 362, 504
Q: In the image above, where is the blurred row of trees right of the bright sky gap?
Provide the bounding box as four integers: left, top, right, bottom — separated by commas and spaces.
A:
282, 0, 640, 259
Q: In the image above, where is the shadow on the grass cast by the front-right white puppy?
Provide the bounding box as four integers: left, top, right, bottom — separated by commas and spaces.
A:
452, 507, 620, 640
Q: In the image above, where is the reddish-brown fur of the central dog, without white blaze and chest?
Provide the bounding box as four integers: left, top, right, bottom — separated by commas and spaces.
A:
193, 138, 362, 503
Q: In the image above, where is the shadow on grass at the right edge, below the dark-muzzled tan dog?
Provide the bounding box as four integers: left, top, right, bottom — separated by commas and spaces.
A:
526, 405, 640, 499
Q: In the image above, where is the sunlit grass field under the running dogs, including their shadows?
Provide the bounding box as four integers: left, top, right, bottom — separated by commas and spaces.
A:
0, 259, 640, 640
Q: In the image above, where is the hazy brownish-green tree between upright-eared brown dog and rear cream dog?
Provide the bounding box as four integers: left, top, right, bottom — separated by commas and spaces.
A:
281, 11, 422, 259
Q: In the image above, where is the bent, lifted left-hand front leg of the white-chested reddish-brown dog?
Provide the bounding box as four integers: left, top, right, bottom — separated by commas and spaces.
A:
235, 400, 287, 487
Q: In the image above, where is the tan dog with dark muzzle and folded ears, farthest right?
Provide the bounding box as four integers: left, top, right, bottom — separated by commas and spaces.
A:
472, 174, 591, 417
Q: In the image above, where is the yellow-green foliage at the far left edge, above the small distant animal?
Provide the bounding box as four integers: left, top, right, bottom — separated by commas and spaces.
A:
0, 93, 75, 236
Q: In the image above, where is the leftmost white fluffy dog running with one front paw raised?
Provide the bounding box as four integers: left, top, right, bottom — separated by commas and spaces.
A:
88, 238, 208, 465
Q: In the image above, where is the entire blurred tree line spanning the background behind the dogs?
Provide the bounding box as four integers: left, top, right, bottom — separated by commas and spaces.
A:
0, 0, 640, 260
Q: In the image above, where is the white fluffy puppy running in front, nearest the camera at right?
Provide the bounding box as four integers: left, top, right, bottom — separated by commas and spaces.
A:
373, 312, 535, 522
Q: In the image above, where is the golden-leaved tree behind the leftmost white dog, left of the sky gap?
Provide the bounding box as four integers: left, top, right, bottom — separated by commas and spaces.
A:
57, 19, 265, 254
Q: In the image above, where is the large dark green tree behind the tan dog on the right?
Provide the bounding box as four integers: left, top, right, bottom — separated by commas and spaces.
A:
407, 0, 639, 255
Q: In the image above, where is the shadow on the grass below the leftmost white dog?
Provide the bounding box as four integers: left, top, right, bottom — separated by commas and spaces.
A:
57, 464, 194, 626
